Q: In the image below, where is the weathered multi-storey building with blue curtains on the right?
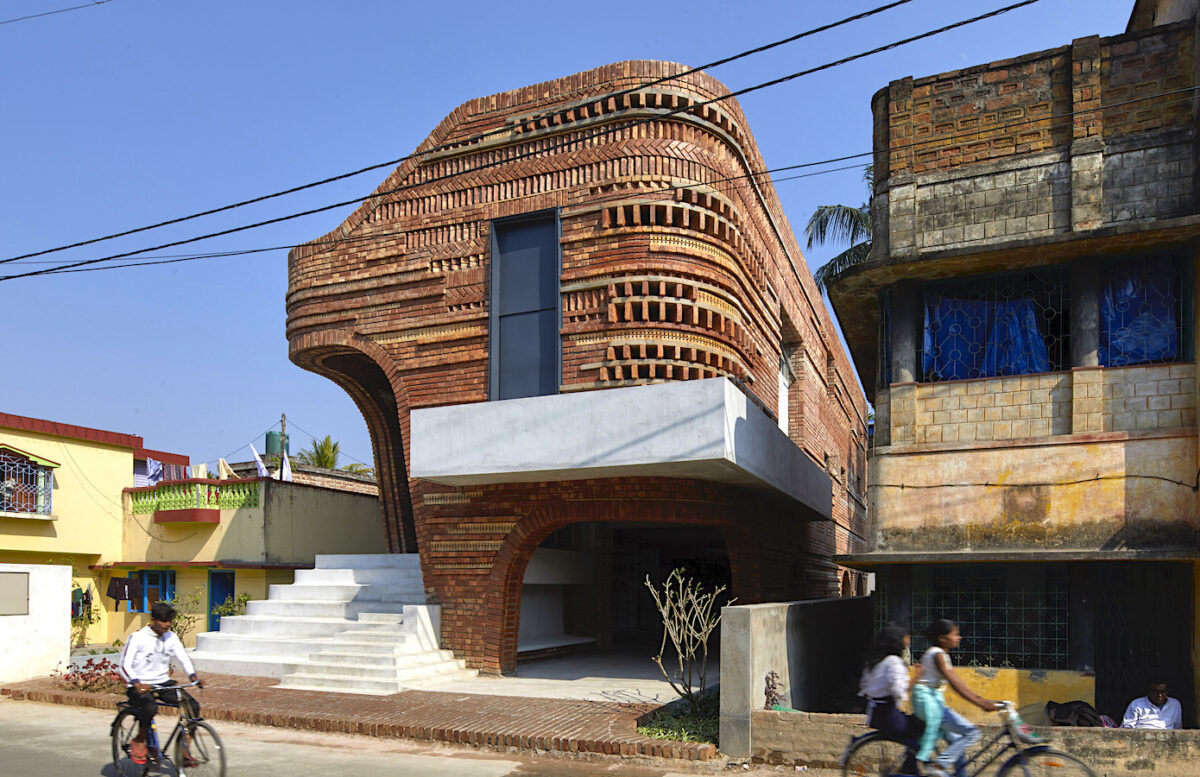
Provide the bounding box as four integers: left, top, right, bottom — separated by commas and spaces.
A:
830, 2, 1200, 722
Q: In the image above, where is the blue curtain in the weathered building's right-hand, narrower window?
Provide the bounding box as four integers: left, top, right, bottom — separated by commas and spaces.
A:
1099, 258, 1180, 367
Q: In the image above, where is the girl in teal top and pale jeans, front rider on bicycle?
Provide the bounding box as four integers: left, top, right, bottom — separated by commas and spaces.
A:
912, 619, 1003, 777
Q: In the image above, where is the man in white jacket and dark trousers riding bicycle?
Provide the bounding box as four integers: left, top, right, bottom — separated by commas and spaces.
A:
120, 602, 204, 764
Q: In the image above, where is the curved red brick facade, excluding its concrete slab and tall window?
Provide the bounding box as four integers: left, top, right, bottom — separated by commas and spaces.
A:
287, 61, 865, 669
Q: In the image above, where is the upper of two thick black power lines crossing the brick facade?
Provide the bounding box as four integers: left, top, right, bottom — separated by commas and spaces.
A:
0, 0, 912, 264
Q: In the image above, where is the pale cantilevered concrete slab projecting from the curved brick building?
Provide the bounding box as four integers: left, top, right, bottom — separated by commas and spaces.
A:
410, 378, 833, 519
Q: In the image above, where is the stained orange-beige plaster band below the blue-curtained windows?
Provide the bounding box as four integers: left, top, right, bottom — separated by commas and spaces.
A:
868, 428, 1200, 550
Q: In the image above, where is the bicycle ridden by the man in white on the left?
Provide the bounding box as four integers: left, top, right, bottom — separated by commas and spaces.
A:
113, 682, 226, 777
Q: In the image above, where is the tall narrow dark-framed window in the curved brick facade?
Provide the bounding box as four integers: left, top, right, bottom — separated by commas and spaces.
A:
491, 212, 562, 399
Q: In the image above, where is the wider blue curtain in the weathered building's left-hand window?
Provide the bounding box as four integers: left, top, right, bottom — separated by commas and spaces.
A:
922, 295, 1050, 380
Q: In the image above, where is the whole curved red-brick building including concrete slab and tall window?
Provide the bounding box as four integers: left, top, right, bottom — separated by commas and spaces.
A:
287, 61, 866, 671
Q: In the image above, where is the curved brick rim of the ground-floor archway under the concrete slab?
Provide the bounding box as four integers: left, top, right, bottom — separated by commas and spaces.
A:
478, 498, 761, 673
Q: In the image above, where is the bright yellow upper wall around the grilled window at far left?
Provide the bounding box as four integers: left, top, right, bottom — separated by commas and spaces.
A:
0, 428, 133, 564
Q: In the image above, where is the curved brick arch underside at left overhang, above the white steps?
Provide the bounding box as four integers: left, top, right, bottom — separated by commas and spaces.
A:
290, 330, 418, 553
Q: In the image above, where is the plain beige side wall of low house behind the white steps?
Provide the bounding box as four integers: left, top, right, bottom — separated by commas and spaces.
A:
265, 482, 388, 565
